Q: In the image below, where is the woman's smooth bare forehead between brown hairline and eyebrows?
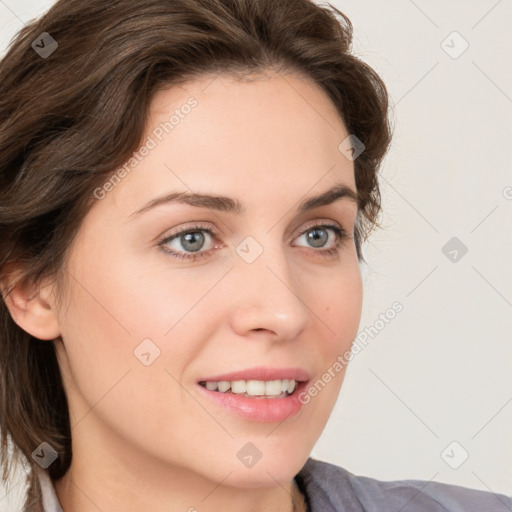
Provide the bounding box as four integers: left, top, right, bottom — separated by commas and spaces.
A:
96, 70, 355, 218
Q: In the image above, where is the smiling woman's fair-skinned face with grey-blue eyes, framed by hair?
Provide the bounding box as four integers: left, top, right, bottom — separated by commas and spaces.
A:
50, 71, 362, 486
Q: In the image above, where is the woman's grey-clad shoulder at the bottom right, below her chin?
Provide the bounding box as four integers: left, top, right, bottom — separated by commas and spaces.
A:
296, 458, 512, 512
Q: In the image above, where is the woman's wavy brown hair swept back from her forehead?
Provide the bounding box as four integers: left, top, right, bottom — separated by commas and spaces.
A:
0, 0, 391, 510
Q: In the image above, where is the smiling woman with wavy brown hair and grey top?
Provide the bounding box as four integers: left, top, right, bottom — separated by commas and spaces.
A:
0, 0, 510, 512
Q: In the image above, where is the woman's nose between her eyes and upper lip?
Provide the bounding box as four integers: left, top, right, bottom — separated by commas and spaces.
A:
229, 243, 314, 341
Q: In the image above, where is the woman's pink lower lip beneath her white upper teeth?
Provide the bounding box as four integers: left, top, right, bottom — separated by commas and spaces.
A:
198, 382, 307, 423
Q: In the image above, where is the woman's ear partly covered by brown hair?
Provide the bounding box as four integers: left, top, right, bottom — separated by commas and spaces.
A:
0, 266, 60, 340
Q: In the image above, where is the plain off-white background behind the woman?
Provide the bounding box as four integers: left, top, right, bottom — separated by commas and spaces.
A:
0, 0, 512, 510
